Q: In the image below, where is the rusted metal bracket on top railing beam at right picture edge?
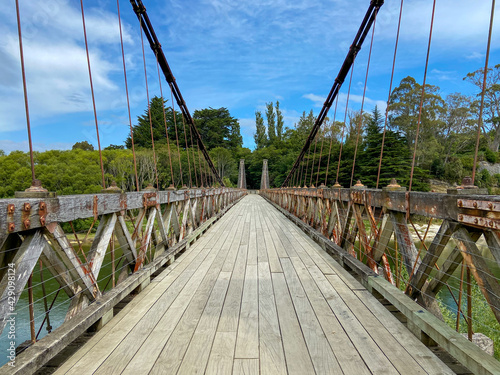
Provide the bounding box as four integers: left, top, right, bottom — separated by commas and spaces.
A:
457, 199, 500, 230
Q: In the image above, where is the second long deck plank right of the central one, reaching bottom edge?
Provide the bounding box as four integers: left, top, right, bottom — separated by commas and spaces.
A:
272, 273, 315, 375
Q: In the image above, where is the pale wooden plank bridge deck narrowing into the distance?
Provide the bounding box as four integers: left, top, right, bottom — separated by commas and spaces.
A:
56, 195, 452, 375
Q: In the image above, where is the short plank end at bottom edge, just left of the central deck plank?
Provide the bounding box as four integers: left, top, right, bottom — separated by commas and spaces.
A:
205, 332, 236, 375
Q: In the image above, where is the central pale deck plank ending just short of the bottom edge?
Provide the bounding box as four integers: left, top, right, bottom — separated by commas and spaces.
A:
235, 262, 259, 358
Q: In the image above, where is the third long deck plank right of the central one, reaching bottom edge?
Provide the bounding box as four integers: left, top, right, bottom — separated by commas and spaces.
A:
281, 258, 342, 374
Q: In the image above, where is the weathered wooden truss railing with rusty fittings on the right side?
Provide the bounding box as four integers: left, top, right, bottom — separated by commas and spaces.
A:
260, 184, 500, 369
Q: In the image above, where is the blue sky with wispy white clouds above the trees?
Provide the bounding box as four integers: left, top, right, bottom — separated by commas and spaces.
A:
0, 0, 500, 152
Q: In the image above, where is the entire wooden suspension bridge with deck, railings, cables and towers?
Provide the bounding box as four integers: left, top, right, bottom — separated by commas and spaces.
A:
0, 0, 500, 374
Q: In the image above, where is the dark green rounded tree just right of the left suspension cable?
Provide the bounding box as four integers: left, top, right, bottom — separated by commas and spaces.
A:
193, 108, 243, 150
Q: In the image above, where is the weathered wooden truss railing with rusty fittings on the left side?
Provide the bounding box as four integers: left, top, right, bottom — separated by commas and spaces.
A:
0, 188, 246, 350
